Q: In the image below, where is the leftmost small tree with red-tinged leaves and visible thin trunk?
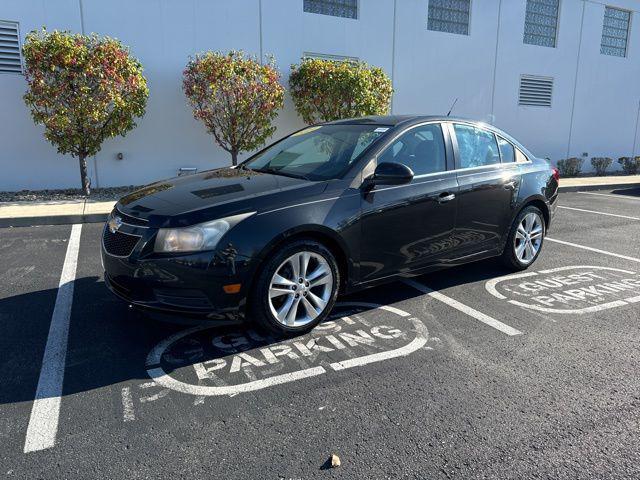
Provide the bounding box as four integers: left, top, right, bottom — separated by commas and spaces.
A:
23, 29, 149, 195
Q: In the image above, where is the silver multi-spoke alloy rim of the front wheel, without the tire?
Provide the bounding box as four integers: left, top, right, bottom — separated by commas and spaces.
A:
269, 251, 334, 327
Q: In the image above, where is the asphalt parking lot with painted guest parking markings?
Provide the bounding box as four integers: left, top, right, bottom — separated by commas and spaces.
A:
0, 188, 640, 479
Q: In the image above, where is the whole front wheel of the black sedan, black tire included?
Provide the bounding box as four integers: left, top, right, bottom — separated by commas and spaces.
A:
248, 240, 340, 336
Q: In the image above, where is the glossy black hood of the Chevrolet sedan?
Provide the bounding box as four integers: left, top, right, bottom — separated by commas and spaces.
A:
116, 168, 322, 226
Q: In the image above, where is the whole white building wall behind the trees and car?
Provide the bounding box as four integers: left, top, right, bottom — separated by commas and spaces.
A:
0, 0, 640, 190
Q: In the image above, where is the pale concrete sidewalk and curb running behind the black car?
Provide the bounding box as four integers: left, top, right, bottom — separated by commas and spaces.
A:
0, 175, 640, 228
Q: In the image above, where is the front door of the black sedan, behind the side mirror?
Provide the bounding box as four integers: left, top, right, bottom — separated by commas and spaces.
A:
360, 122, 458, 282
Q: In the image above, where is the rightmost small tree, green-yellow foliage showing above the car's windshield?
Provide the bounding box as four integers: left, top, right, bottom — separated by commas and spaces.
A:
289, 58, 393, 124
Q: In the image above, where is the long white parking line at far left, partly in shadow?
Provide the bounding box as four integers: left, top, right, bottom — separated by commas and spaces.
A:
24, 225, 82, 453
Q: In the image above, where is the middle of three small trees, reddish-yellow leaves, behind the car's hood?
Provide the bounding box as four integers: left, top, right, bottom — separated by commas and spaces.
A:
183, 50, 284, 165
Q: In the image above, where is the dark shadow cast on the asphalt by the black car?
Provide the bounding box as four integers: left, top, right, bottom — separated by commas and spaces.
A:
0, 260, 510, 404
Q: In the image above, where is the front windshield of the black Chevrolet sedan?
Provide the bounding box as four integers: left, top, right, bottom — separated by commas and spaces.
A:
242, 124, 391, 180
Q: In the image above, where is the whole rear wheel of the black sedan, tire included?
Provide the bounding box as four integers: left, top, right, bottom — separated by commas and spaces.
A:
501, 206, 547, 271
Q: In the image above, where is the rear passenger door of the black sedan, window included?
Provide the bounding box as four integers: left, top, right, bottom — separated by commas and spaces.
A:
449, 123, 521, 257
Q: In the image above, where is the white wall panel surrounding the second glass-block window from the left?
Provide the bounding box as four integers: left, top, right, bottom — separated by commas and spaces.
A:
393, 0, 502, 120
